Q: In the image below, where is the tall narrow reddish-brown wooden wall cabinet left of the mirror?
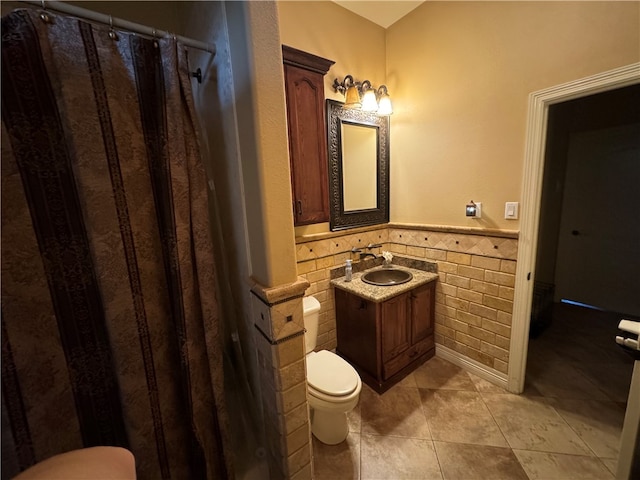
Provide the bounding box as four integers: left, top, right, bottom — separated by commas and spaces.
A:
282, 45, 335, 226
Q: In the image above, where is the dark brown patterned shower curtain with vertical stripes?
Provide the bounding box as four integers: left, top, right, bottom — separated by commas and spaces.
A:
1, 10, 231, 479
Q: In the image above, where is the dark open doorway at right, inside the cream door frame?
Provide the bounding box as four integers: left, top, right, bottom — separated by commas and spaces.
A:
525, 84, 640, 403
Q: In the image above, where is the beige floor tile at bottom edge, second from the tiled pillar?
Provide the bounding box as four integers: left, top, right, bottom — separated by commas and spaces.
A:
362, 435, 442, 480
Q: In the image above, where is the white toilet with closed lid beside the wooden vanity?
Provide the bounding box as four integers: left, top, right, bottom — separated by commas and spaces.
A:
303, 297, 362, 445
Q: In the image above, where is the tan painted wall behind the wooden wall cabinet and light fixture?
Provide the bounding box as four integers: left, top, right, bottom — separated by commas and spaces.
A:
277, 1, 386, 236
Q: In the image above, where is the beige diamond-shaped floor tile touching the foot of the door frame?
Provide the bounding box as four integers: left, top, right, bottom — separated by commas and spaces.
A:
482, 393, 591, 455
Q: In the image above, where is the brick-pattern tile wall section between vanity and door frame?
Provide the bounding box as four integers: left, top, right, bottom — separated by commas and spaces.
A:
387, 229, 517, 374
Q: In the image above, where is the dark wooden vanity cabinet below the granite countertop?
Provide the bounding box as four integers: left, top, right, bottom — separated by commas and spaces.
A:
335, 282, 435, 393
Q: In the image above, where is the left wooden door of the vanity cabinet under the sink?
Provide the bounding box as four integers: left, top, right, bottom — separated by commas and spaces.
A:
382, 294, 411, 362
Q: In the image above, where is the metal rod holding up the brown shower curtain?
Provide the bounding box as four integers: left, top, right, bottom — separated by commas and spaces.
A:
19, 0, 216, 55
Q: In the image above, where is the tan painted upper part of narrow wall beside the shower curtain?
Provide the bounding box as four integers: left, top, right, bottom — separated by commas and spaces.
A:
238, 2, 297, 287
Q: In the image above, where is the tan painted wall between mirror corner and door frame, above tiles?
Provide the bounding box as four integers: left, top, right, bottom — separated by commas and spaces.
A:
386, 2, 640, 230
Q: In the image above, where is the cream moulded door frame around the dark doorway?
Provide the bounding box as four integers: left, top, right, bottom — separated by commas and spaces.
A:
507, 63, 640, 393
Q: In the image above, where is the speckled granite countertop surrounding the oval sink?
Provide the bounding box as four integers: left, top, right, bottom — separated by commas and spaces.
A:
331, 266, 438, 302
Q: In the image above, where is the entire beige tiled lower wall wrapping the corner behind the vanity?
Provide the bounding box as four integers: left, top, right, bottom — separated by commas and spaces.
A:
296, 225, 518, 374
